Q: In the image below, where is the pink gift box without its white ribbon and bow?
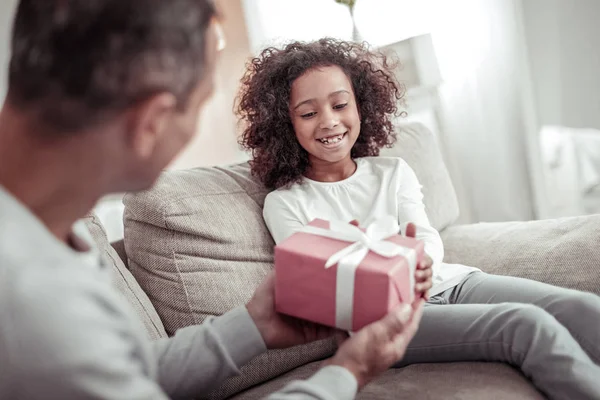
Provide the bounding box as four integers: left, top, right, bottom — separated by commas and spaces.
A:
275, 219, 424, 331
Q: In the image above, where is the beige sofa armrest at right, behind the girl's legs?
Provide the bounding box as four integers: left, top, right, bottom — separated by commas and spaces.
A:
442, 215, 600, 294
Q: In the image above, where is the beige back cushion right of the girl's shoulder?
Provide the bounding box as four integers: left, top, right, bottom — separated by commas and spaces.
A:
381, 123, 459, 231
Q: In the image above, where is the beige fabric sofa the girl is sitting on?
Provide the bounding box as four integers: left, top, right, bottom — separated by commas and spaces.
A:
88, 125, 600, 400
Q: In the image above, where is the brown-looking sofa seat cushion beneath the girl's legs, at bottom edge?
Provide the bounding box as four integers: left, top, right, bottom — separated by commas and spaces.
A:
232, 362, 544, 400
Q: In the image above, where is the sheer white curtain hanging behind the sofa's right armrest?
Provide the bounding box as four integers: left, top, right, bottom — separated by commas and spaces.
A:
432, 0, 537, 222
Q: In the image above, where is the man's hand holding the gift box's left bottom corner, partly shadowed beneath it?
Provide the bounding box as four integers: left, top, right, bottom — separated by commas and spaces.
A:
246, 271, 342, 349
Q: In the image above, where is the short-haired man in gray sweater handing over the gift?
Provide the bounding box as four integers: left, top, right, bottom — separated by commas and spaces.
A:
0, 0, 421, 399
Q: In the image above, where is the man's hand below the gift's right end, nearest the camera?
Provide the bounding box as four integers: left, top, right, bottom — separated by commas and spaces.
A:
325, 299, 424, 389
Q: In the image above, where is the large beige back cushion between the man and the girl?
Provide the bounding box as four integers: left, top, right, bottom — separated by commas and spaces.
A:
124, 164, 273, 335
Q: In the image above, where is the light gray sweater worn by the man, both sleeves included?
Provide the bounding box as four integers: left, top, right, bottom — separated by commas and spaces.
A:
0, 186, 357, 400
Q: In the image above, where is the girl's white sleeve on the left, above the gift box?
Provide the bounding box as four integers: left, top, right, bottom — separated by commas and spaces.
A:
263, 191, 304, 244
